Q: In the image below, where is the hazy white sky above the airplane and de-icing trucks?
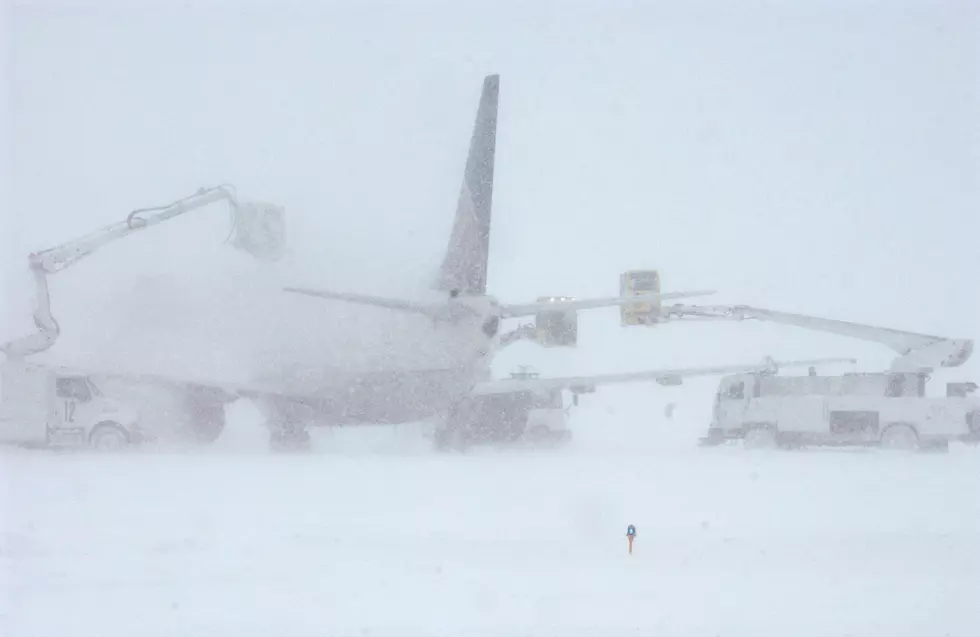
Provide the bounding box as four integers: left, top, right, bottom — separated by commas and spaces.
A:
0, 0, 980, 410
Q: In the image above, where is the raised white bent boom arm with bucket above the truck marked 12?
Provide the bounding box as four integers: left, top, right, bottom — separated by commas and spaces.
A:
0, 185, 285, 359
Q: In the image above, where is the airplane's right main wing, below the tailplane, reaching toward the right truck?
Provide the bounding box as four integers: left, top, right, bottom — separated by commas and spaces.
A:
472, 358, 857, 395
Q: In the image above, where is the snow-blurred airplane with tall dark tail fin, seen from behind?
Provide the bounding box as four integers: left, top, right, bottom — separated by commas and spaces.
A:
228, 74, 844, 448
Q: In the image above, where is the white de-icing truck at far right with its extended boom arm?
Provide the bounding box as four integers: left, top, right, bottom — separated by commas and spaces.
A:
672, 306, 980, 450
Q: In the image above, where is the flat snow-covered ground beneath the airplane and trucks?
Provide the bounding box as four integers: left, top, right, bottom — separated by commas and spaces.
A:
0, 412, 980, 637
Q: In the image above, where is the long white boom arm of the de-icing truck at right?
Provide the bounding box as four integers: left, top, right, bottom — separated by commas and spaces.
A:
664, 305, 973, 373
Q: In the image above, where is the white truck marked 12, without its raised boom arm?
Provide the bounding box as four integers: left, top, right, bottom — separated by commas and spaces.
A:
0, 360, 143, 450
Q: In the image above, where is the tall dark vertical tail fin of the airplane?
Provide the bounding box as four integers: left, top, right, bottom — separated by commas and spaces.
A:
437, 75, 500, 294
